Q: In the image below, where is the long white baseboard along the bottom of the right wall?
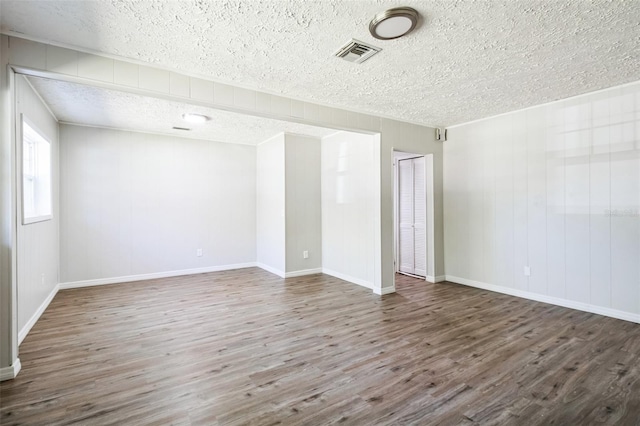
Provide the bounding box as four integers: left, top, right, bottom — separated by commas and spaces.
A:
446, 275, 640, 323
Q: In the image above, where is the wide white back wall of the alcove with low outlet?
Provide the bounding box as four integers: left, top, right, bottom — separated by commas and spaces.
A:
60, 125, 256, 283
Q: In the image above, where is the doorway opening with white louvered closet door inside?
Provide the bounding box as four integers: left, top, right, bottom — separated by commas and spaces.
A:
394, 151, 435, 281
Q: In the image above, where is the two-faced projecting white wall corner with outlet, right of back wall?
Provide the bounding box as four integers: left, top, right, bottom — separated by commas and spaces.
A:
257, 133, 322, 277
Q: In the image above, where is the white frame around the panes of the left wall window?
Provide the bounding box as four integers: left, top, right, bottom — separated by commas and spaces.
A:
19, 113, 53, 225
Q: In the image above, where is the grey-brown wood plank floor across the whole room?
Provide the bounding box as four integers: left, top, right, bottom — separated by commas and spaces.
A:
0, 268, 640, 425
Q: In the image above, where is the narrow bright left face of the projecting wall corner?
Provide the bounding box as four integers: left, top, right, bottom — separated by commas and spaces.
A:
256, 133, 286, 276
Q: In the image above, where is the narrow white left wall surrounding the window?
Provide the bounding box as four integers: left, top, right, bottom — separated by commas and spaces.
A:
15, 76, 60, 337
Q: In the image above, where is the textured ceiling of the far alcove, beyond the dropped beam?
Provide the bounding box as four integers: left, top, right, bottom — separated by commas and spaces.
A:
29, 77, 336, 145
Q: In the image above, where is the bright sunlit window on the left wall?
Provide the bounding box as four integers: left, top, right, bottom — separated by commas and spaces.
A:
22, 116, 52, 225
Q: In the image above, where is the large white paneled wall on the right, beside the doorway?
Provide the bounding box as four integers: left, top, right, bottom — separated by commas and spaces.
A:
444, 83, 640, 321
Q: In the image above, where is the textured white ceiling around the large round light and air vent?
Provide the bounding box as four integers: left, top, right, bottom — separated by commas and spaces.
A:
0, 0, 640, 125
